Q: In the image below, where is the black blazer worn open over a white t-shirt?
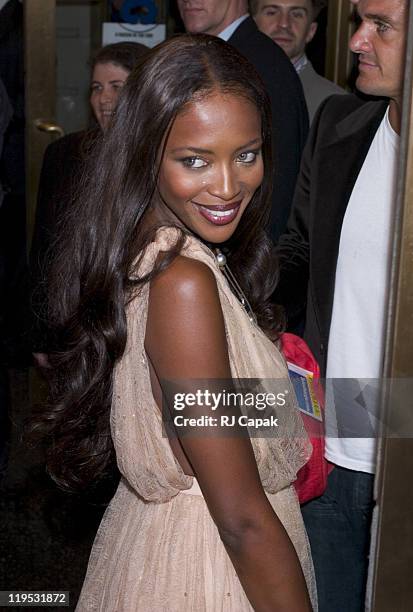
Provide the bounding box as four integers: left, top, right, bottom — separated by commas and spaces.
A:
275, 95, 388, 376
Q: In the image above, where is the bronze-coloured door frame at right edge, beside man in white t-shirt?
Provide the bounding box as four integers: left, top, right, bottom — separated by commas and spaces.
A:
370, 2, 413, 612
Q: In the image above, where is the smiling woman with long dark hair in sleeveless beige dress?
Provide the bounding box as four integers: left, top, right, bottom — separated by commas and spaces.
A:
35, 35, 316, 612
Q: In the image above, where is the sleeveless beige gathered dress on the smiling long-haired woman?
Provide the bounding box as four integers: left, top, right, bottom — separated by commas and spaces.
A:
76, 228, 317, 612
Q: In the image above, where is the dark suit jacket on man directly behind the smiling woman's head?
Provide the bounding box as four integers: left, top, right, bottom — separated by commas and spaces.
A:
228, 17, 308, 241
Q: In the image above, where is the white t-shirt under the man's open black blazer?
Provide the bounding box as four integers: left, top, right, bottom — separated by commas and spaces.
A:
325, 109, 399, 473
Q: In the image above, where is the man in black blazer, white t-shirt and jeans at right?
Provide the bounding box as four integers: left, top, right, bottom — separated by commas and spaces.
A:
276, 0, 408, 612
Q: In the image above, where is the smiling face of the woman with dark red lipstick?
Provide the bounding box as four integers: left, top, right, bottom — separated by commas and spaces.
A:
153, 92, 264, 244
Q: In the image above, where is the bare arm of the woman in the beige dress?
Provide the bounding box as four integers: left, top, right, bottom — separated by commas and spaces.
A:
145, 256, 311, 612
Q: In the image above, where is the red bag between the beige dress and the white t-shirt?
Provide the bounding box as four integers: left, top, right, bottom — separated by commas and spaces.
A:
281, 333, 333, 504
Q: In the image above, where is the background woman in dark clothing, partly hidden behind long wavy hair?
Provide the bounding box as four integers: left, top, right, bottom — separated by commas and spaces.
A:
30, 42, 149, 358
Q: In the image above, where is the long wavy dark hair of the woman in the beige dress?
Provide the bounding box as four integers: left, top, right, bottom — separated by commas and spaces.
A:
32, 35, 281, 489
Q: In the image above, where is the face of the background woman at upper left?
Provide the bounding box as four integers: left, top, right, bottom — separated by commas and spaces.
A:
90, 63, 129, 130
